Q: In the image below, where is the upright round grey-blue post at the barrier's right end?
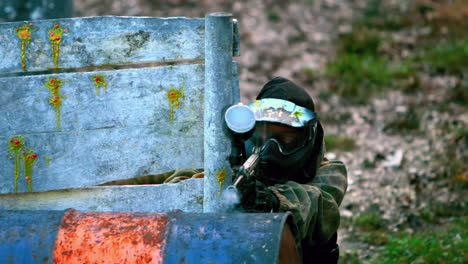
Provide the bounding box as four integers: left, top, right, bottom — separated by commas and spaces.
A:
203, 13, 233, 212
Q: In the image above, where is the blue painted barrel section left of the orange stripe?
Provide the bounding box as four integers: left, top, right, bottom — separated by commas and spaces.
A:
0, 210, 65, 264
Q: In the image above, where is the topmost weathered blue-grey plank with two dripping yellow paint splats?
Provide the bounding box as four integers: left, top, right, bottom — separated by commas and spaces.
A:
0, 16, 239, 73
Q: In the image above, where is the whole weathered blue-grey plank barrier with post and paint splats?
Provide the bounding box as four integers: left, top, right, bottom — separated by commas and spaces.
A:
0, 13, 239, 212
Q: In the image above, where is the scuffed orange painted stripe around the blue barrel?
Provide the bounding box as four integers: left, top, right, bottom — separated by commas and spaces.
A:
53, 209, 168, 264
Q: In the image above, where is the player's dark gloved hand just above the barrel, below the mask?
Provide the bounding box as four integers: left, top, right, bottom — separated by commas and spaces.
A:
239, 181, 279, 212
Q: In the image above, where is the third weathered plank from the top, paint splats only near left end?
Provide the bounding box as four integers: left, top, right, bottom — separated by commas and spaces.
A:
0, 122, 203, 193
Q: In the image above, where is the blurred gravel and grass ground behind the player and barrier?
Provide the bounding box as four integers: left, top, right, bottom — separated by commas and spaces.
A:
0, 0, 468, 263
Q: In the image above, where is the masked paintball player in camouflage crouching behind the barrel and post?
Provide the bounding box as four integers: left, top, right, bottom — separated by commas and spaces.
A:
239, 77, 347, 263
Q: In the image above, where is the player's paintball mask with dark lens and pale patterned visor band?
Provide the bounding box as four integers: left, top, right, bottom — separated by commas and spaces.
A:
249, 98, 319, 185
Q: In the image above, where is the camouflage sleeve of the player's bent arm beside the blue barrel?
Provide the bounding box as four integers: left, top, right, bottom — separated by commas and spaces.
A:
270, 161, 347, 246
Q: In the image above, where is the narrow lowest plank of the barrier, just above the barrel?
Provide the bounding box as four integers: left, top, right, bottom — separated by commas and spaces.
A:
0, 179, 203, 213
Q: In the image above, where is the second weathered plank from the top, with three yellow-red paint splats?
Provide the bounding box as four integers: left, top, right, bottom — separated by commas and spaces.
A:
0, 64, 204, 136
